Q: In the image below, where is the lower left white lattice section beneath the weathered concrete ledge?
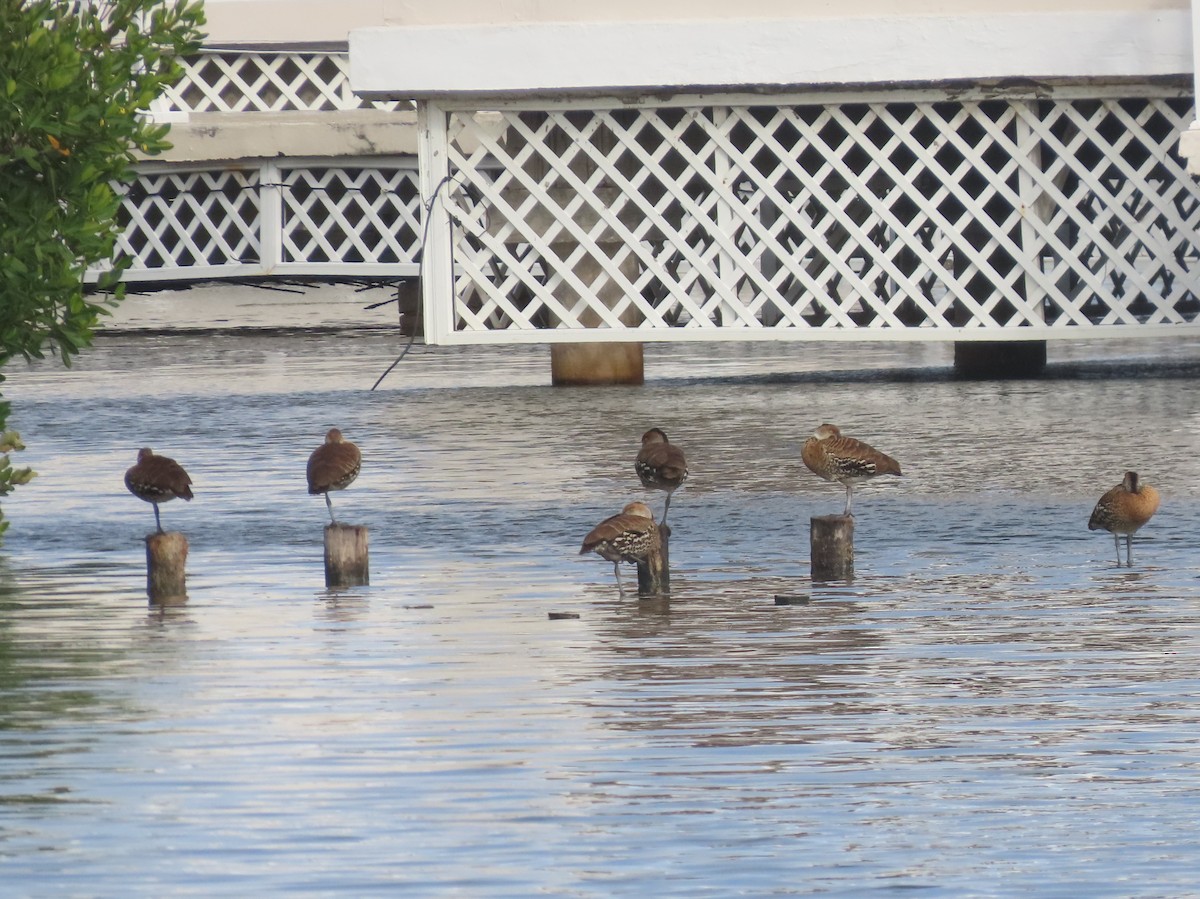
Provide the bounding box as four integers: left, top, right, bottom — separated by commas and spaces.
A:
91, 158, 421, 282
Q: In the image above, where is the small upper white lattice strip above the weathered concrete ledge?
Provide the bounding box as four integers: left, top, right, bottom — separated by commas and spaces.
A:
163, 52, 408, 113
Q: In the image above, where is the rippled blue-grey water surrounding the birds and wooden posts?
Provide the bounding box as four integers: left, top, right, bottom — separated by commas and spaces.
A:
0, 335, 1200, 897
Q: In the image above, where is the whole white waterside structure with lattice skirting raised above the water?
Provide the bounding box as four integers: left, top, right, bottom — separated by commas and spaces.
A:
96, 0, 1200, 377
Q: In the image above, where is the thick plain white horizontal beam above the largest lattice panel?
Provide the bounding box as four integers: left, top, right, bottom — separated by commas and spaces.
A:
350, 10, 1194, 98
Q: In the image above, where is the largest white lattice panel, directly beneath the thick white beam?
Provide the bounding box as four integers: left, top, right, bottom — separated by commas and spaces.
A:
424, 86, 1200, 342
